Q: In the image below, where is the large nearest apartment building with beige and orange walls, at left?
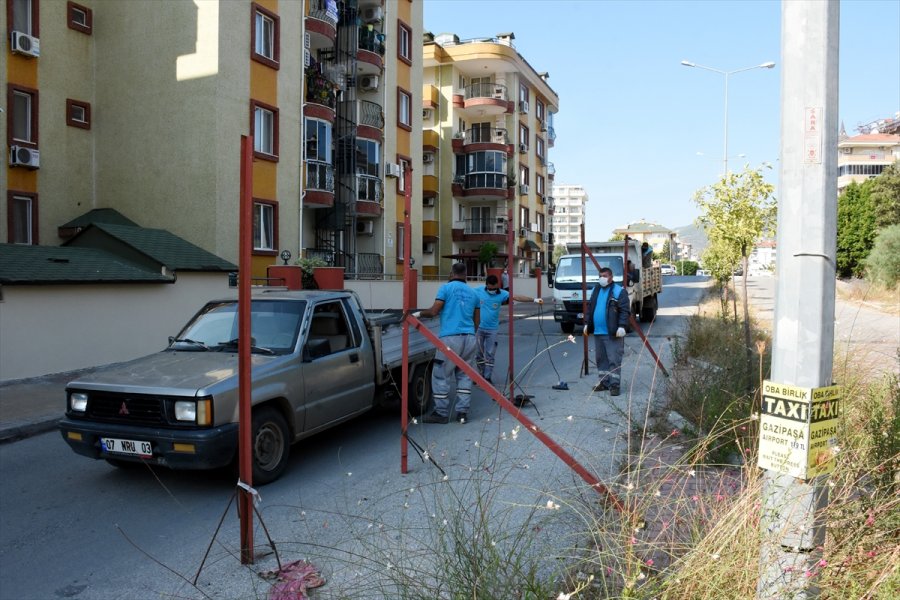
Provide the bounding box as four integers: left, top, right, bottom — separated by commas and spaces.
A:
0, 0, 422, 277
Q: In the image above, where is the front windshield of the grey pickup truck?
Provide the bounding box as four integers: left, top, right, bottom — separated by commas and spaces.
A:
169, 300, 306, 354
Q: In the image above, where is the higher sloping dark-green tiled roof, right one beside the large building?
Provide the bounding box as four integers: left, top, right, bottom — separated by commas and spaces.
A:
66, 222, 237, 272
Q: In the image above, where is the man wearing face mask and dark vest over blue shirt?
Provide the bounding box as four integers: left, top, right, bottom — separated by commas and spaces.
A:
584, 267, 631, 396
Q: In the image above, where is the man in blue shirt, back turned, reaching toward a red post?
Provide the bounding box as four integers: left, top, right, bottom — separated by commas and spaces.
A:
404, 262, 480, 424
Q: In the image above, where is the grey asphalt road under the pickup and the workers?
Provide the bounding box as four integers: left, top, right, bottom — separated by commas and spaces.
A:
0, 277, 706, 600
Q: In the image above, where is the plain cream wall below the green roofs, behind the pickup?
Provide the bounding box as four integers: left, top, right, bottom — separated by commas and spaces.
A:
0, 273, 237, 381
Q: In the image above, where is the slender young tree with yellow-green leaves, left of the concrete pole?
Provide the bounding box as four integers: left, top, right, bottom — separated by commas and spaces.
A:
694, 166, 778, 389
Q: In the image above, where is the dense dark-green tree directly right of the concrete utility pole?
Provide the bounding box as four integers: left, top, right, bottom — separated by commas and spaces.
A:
836, 179, 876, 277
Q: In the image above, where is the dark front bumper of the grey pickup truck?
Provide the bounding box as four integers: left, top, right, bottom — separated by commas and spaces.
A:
59, 417, 238, 469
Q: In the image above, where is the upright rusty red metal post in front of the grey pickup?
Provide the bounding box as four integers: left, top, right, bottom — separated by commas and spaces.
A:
237, 135, 254, 565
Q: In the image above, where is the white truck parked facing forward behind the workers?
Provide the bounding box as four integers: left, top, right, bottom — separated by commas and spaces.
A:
553, 240, 662, 333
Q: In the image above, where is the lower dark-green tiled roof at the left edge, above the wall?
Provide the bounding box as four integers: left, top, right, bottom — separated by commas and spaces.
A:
0, 244, 175, 284
